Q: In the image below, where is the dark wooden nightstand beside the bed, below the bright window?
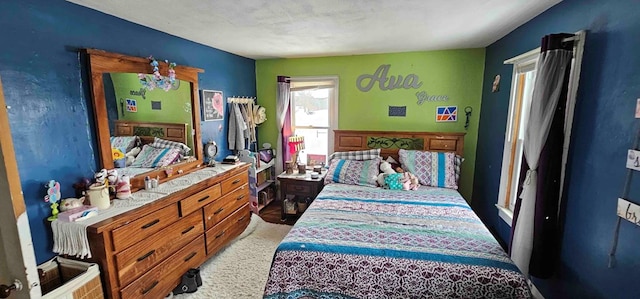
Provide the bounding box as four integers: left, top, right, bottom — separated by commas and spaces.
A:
278, 169, 327, 219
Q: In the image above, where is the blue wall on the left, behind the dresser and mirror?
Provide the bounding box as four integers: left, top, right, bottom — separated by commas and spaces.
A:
0, 0, 256, 263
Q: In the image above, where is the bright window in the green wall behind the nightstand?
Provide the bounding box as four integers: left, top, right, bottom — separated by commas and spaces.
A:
291, 77, 338, 165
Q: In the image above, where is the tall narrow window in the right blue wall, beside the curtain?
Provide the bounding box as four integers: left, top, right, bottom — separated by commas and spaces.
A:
497, 50, 539, 224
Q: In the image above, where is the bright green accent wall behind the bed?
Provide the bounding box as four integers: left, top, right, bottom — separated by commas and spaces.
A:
256, 49, 485, 201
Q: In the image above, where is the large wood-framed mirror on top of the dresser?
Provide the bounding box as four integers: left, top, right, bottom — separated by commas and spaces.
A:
85, 49, 203, 190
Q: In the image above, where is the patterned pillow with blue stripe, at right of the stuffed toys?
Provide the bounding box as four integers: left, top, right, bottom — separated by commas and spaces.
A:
398, 149, 458, 189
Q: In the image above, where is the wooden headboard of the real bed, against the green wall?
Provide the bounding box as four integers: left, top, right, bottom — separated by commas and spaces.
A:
333, 130, 465, 161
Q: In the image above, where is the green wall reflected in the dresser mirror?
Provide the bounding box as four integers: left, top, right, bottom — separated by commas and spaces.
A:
110, 73, 193, 148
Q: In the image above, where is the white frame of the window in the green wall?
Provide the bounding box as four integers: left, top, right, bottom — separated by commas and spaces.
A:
289, 76, 340, 164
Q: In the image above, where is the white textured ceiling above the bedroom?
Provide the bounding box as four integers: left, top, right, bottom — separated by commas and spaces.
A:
67, 0, 560, 59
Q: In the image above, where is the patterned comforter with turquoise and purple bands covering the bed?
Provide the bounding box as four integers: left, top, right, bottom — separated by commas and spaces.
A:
264, 184, 531, 298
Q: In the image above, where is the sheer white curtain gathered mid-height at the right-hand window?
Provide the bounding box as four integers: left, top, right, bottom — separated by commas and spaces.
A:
511, 35, 573, 275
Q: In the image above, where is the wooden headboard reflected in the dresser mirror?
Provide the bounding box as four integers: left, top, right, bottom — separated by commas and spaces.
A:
115, 120, 187, 144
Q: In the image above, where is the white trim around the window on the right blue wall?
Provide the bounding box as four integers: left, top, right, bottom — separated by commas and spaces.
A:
495, 30, 587, 226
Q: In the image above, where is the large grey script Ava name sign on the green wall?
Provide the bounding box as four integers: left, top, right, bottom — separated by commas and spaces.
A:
356, 64, 422, 92
